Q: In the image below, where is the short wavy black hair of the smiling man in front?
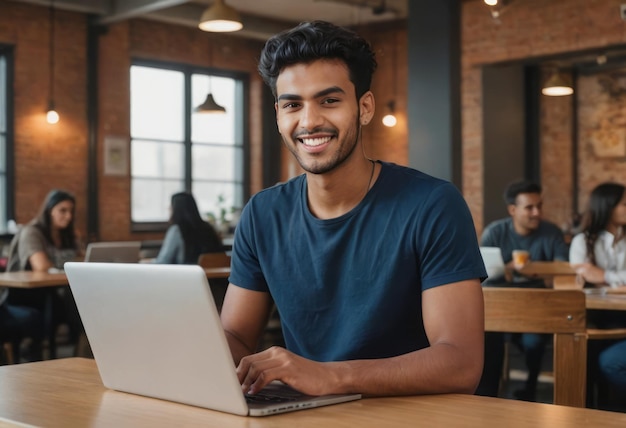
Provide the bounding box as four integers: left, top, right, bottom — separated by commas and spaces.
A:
258, 21, 377, 100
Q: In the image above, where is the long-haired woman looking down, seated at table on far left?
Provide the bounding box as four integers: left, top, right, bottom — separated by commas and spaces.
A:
7, 189, 82, 360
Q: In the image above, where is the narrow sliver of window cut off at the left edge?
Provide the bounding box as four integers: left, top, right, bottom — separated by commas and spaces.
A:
0, 45, 13, 234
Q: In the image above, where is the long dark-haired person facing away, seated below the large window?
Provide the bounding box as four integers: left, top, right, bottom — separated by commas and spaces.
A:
154, 192, 224, 264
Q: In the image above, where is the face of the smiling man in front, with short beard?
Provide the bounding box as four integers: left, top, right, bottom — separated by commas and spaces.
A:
275, 60, 373, 174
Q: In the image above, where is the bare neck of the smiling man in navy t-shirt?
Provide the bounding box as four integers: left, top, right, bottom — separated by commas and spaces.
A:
306, 157, 372, 219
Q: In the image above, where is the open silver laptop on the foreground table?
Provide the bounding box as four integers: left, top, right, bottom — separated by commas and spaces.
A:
65, 262, 361, 416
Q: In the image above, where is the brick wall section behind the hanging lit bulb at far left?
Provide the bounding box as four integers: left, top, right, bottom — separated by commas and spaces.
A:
0, 2, 87, 241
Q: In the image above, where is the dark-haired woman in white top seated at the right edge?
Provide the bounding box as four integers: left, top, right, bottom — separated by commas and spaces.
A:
570, 183, 626, 411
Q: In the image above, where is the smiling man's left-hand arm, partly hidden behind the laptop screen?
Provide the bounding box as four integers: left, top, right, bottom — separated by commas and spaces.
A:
220, 284, 272, 364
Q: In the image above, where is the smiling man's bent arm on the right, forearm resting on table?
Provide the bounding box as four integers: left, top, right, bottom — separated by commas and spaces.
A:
237, 279, 484, 395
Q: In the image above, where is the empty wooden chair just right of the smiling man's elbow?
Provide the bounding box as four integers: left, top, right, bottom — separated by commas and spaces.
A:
483, 287, 587, 407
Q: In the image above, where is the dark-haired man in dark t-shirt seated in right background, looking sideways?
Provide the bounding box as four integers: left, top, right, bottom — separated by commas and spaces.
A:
477, 181, 569, 401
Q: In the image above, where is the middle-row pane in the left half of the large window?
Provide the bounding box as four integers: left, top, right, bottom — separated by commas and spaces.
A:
131, 140, 185, 179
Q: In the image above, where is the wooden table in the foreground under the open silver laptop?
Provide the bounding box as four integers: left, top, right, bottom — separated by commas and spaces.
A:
0, 358, 626, 428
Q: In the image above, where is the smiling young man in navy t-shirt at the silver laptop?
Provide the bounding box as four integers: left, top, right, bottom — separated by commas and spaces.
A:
221, 21, 486, 395
